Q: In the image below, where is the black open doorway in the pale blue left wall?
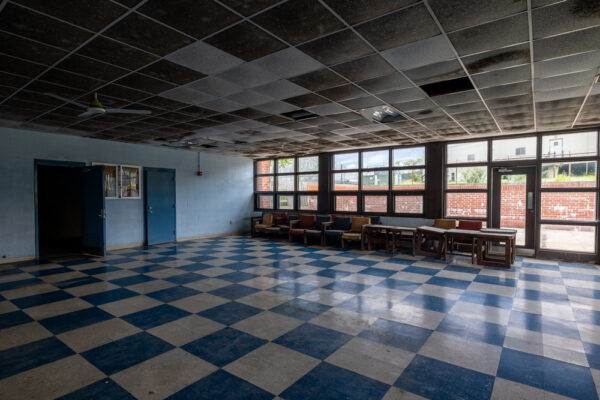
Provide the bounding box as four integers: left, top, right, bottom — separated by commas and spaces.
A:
37, 165, 83, 258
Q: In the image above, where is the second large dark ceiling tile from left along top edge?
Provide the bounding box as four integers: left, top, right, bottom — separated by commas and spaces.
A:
138, 0, 240, 39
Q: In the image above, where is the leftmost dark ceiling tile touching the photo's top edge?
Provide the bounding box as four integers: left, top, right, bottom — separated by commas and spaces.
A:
11, 0, 127, 31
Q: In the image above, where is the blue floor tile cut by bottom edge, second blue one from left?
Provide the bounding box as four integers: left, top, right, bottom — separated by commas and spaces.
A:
167, 370, 273, 400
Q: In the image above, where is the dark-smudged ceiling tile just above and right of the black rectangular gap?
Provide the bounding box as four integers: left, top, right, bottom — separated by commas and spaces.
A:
462, 43, 531, 74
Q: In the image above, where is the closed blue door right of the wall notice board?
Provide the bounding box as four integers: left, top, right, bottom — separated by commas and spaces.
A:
144, 168, 175, 245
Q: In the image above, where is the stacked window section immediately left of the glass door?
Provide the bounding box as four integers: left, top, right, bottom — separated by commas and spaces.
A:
444, 141, 488, 219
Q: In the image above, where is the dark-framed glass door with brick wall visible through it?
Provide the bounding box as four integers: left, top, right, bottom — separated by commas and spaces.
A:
492, 166, 536, 249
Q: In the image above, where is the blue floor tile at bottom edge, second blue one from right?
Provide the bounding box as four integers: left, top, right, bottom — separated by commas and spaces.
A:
394, 355, 494, 400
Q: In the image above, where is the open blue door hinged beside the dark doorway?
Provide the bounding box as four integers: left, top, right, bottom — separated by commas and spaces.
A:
81, 165, 106, 256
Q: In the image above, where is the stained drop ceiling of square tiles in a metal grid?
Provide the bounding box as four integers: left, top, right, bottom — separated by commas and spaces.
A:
0, 0, 600, 158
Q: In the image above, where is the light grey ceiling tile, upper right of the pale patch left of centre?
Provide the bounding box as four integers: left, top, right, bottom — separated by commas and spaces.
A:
252, 47, 323, 78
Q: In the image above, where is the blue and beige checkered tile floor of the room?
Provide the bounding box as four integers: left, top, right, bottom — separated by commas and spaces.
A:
0, 236, 600, 400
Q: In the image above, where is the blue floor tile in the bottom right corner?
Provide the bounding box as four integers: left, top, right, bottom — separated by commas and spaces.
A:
496, 348, 598, 400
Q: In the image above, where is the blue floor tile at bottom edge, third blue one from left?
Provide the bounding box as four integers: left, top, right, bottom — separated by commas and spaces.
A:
281, 363, 389, 400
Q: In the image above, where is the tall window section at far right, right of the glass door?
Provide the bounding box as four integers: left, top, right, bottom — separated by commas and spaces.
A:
539, 132, 598, 253
